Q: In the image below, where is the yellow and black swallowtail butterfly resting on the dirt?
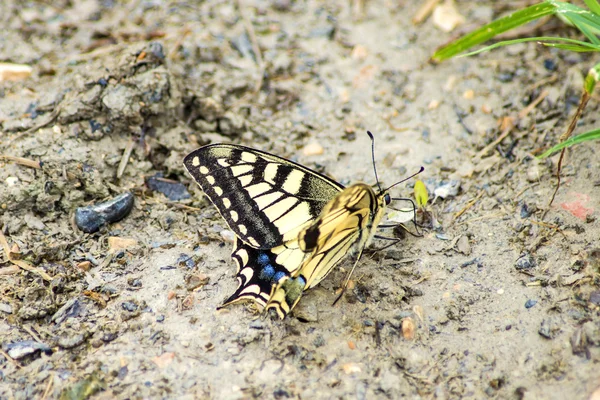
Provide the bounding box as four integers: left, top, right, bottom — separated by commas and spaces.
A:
183, 132, 422, 318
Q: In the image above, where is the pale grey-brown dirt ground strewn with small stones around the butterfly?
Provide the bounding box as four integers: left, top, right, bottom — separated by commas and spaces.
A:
0, 0, 600, 399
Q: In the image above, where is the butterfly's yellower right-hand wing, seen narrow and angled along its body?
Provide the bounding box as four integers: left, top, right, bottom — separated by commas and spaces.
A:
266, 183, 386, 318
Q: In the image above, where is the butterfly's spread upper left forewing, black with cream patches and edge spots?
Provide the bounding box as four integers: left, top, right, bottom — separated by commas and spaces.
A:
183, 144, 343, 250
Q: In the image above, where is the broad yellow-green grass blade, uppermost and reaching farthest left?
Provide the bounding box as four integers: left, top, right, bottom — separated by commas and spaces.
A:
432, 2, 561, 61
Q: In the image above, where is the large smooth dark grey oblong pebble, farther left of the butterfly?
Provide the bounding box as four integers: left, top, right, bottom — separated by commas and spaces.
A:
75, 192, 133, 233
